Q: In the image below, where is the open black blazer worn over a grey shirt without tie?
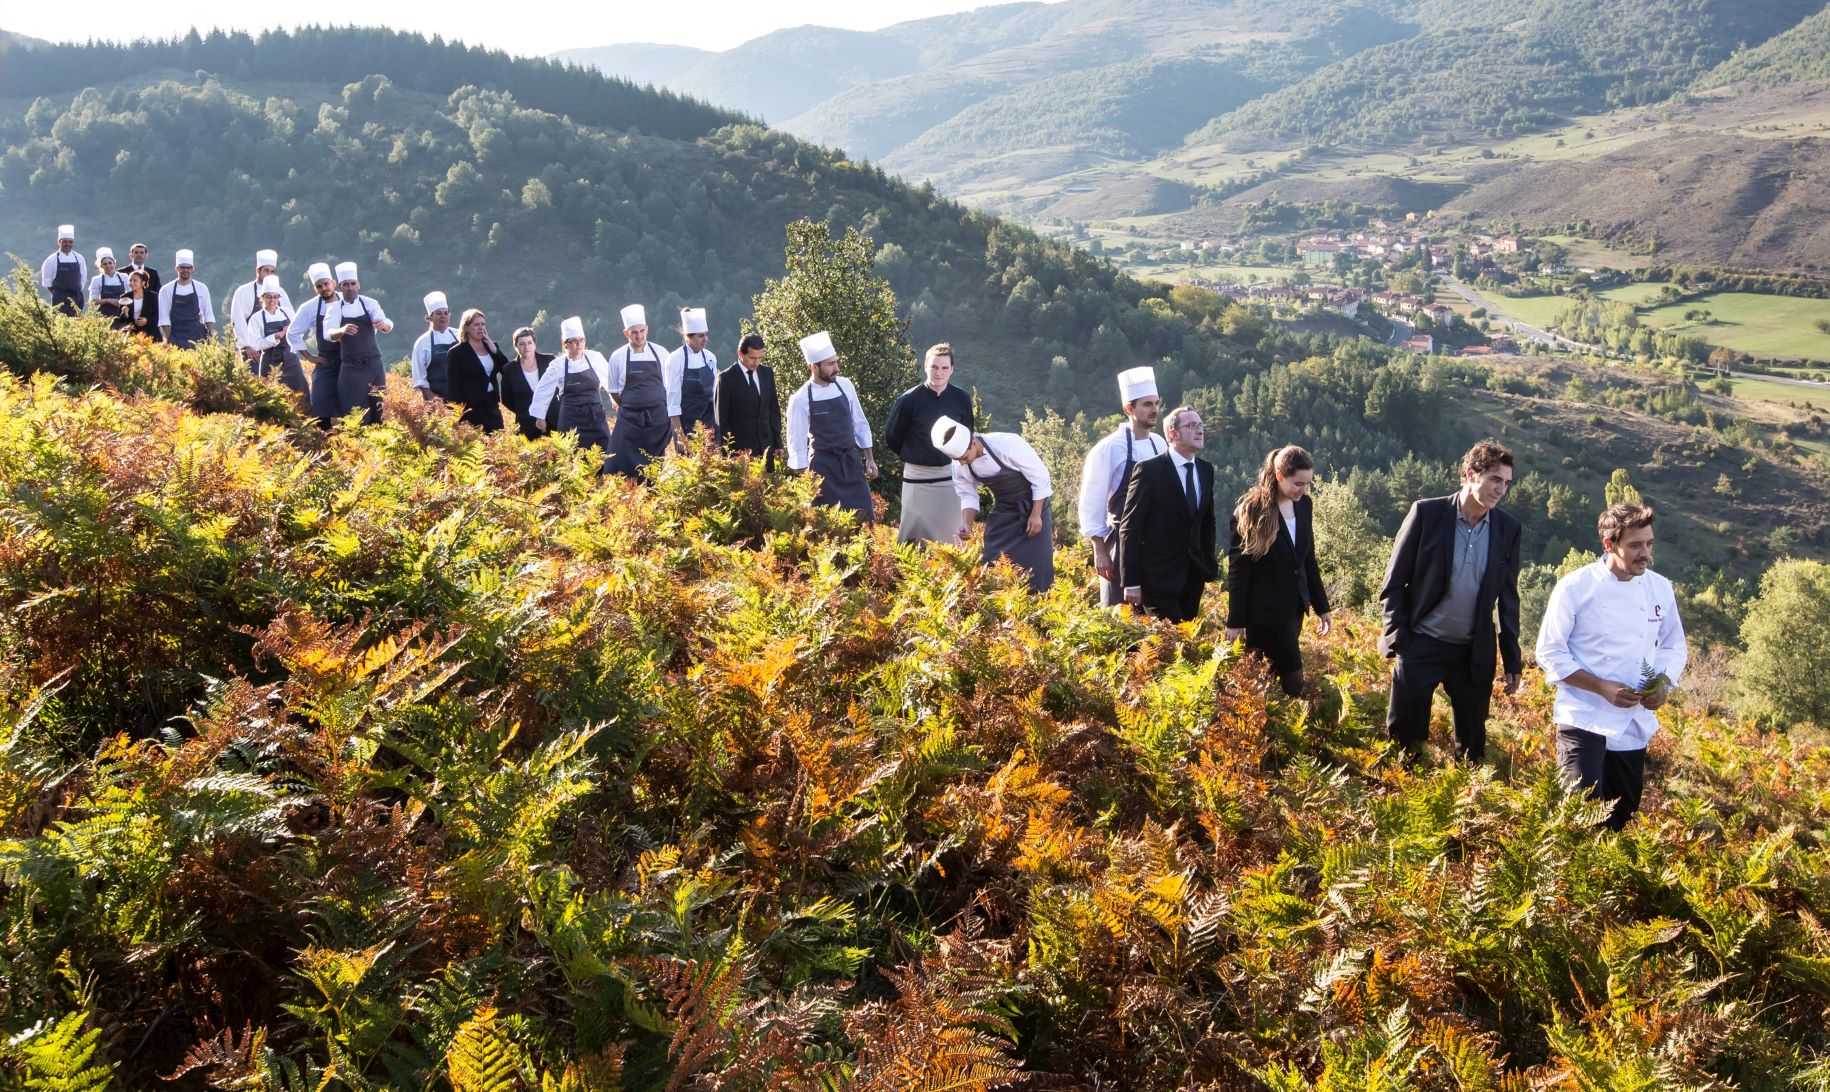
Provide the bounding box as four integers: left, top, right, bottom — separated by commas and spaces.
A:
1378, 496, 1524, 675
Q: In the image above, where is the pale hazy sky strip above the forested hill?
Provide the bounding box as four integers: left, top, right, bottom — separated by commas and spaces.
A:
0, 0, 1032, 56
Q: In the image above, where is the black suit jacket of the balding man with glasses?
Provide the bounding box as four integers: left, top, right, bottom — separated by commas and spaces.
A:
1118, 452, 1221, 596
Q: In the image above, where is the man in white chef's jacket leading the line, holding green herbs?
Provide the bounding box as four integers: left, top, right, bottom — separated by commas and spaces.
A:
1537, 505, 1689, 830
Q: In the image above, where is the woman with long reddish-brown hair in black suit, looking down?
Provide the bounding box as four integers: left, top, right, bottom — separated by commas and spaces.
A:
1226, 444, 1332, 697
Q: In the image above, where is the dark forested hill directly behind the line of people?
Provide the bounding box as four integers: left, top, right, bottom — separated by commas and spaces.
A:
0, 31, 1268, 419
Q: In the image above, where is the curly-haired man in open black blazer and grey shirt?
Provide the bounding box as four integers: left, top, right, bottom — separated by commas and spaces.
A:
1378, 439, 1523, 763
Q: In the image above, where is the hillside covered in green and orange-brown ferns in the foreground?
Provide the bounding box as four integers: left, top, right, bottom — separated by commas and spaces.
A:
0, 274, 1830, 1092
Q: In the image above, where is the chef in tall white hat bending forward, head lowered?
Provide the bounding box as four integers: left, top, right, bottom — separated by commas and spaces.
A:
930, 417, 1054, 593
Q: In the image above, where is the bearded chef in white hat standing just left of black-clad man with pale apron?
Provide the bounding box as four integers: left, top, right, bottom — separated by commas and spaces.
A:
787, 329, 877, 523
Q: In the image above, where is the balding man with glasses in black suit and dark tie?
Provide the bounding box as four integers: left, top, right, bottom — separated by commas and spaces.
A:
1118, 406, 1221, 622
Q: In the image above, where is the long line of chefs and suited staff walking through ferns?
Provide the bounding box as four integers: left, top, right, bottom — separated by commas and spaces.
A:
40, 225, 1687, 829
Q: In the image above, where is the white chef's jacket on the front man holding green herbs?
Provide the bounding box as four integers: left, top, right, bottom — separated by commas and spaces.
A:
1537, 560, 1689, 750
